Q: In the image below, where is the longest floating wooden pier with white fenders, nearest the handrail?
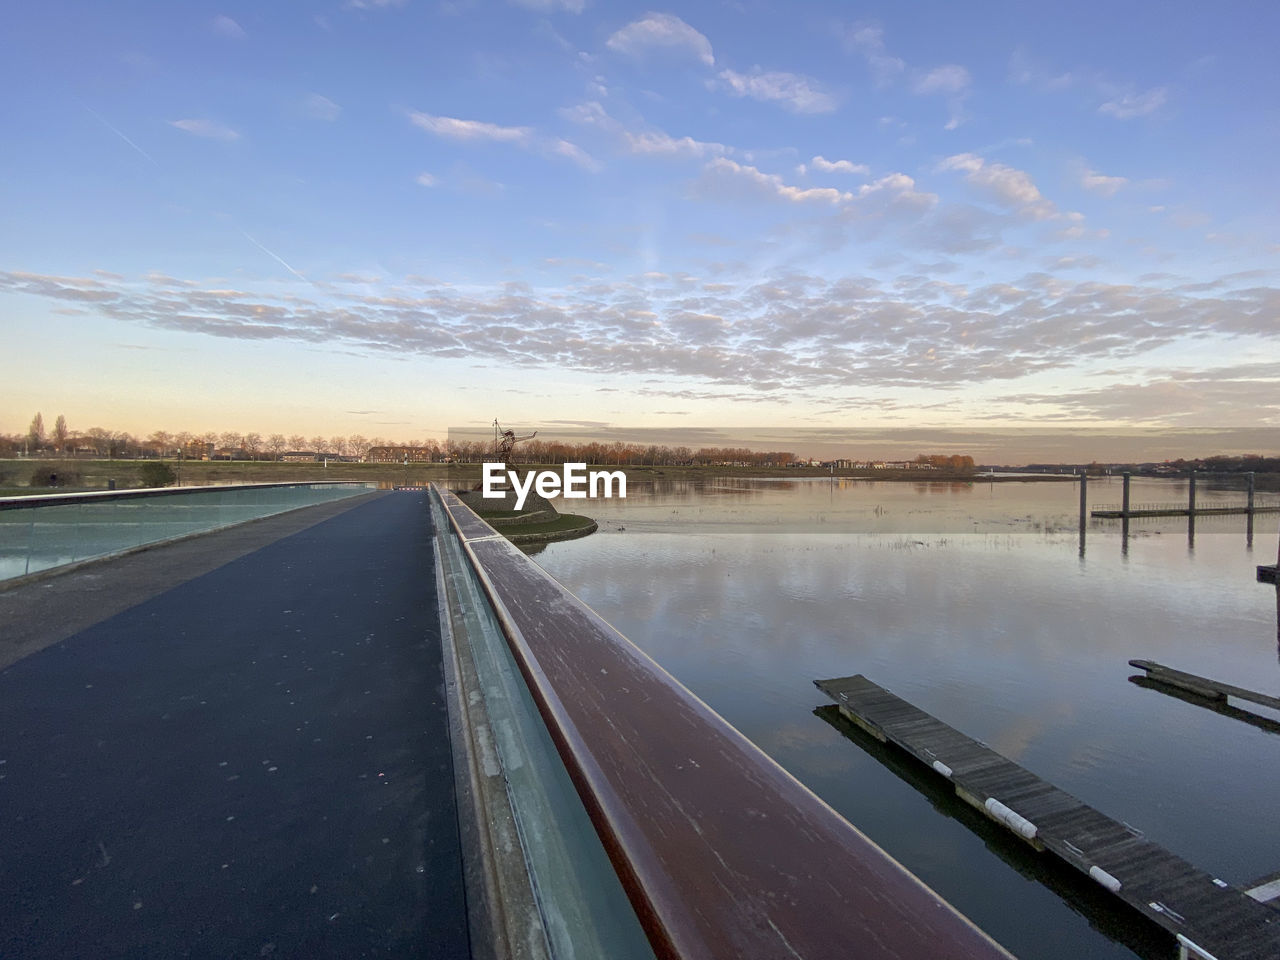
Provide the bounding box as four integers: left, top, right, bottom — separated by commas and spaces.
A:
814, 675, 1280, 960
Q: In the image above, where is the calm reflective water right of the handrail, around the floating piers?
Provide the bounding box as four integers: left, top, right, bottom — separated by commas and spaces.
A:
524, 480, 1280, 960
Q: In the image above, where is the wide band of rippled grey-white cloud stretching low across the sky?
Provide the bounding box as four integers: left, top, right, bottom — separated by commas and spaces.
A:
10, 271, 1280, 407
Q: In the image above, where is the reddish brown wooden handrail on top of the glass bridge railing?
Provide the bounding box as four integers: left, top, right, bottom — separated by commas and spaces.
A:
443, 493, 1010, 960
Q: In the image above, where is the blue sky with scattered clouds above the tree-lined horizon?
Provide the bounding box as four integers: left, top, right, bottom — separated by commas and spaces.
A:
0, 0, 1280, 452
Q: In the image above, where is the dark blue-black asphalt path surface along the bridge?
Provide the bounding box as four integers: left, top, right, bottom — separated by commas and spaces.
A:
0, 493, 468, 960
